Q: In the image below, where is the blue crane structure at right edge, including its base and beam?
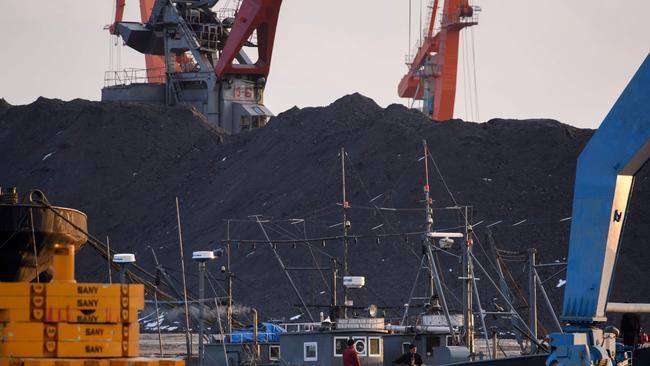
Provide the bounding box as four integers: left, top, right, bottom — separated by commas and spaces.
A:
546, 55, 650, 366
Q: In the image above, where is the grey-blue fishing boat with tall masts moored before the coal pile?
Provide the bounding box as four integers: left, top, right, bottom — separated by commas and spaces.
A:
195, 141, 547, 366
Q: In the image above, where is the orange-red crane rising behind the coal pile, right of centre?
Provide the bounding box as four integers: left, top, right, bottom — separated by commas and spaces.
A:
397, 0, 478, 121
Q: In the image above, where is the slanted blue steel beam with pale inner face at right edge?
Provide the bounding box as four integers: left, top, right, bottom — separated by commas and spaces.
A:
562, 55, 650, 324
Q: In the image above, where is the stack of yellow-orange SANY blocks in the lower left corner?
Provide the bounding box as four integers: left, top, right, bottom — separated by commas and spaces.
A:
0, 244, 184, 366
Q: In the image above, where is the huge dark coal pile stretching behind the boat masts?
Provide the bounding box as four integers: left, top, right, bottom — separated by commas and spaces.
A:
0, 94, 650, 332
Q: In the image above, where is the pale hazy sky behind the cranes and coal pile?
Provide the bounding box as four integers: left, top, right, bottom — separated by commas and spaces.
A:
0, 0, 650, 128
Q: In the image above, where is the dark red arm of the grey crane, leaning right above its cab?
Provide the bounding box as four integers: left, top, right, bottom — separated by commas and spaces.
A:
214, 0, 282, 78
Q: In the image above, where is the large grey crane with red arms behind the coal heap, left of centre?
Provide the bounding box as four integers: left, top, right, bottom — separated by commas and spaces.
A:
102, 0, 282, 134
